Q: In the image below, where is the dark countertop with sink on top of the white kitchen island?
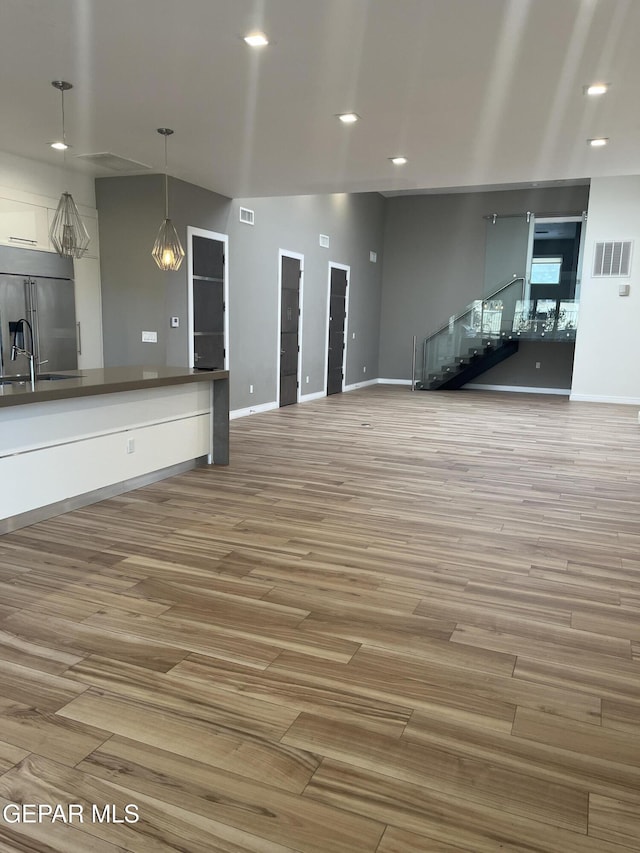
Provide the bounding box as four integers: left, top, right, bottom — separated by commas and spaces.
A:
0, 367, 229, 408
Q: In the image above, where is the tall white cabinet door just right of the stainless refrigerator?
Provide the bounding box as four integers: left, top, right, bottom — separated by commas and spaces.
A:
73, 257, 104, 369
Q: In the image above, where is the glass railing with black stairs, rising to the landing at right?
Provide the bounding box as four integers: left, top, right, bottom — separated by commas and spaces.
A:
416, 278, 578, 391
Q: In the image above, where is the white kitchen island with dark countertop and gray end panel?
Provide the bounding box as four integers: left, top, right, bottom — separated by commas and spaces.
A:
0, 367, 229, 533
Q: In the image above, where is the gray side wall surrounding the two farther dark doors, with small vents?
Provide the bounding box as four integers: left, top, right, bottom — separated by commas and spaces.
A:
229, 193, 385, 408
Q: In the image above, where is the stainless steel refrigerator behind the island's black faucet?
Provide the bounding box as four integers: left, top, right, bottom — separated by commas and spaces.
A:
0, 247, 78, 376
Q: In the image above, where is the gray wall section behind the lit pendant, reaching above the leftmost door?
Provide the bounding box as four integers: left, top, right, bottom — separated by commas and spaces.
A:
96, 175, 231, 367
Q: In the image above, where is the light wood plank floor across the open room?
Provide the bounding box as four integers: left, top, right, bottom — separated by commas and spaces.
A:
0, 387, 640, 853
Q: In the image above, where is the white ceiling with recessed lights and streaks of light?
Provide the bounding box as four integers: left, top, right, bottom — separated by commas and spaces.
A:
0, 0, 640, 197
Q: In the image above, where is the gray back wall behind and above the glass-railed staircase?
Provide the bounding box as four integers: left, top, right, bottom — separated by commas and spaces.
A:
379, 187, 589, 387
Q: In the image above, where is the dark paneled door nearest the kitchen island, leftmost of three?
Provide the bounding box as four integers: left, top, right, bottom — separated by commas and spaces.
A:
191, 235, 226, 370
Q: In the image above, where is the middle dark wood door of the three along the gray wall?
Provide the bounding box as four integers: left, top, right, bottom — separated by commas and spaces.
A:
280, 255, 301, 406
